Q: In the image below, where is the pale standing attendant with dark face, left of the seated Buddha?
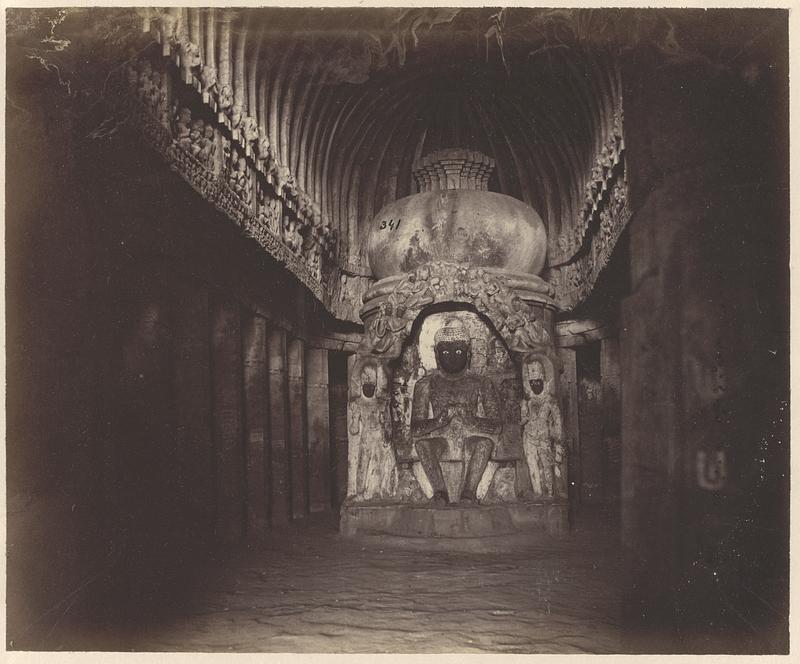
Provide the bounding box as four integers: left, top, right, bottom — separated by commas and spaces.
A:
347, 361, 397, 502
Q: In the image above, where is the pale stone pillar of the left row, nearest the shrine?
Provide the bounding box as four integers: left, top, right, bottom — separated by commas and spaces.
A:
306, 348, 331, 512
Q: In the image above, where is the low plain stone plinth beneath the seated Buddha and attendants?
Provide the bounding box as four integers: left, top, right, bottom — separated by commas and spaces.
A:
340, 500, 569, 539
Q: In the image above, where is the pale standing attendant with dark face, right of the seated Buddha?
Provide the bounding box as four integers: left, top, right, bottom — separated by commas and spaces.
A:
520, 359, 567, 498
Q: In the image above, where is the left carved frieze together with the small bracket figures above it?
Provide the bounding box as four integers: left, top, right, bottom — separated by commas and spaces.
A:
122, 22, 372, 321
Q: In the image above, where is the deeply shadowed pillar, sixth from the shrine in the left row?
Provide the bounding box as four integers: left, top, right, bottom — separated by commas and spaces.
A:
172, 279, 215, 541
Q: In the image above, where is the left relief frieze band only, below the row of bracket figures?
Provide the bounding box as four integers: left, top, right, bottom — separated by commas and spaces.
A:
120, 52, 342, 308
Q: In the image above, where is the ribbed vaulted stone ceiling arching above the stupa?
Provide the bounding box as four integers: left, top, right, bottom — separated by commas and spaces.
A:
178, 8, 620, 268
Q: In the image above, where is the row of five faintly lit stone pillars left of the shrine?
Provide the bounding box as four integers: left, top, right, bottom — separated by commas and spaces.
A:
211, 302, 331, 539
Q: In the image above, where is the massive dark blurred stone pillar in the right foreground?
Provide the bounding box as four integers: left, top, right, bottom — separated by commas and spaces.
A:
620, 40, 788, 638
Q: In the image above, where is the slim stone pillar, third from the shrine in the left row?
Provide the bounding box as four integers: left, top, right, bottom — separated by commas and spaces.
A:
267, 328, 291, 526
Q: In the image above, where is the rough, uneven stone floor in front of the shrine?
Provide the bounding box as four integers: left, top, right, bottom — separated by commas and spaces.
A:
53, 510, 621, 653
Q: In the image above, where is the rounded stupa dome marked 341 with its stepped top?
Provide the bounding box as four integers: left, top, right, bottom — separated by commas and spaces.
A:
367, 148, 547, 279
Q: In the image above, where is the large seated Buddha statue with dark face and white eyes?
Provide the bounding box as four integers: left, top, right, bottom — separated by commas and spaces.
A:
411, 318, 502, 505
